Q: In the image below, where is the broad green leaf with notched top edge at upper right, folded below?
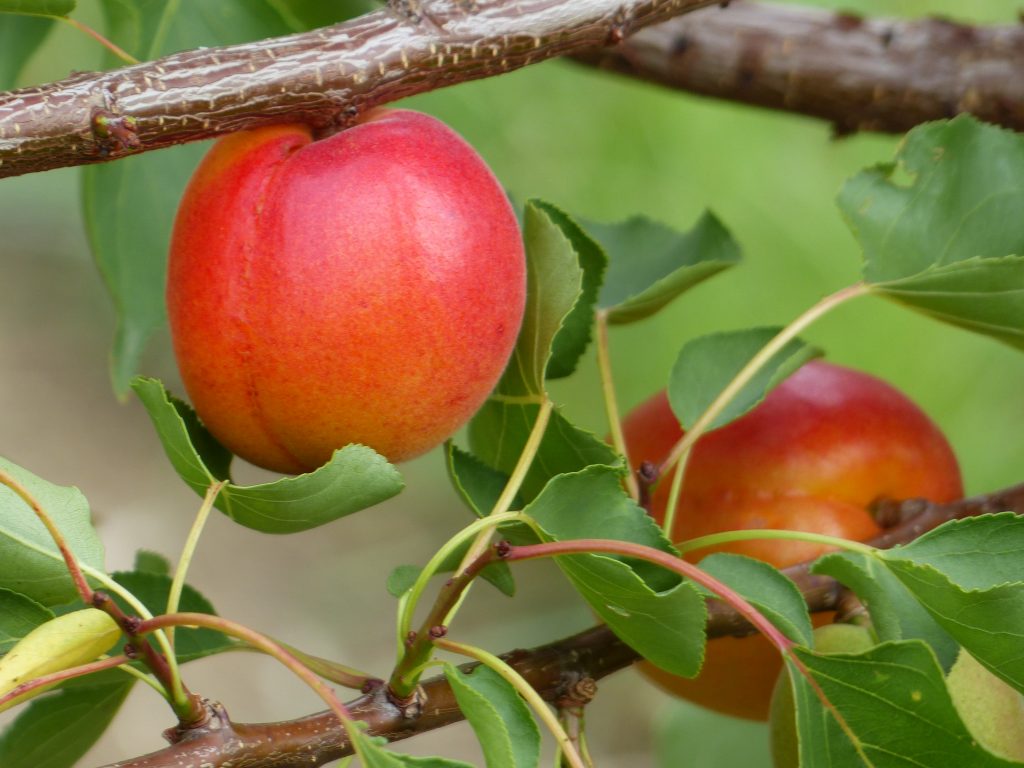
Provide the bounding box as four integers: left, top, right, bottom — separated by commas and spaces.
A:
839, 116, 1024, 348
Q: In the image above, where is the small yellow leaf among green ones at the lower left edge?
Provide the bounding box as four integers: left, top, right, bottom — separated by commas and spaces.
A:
0, 608, 121, 712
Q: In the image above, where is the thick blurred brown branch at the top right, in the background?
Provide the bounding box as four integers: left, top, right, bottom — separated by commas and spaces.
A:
577, 2, 1024, 134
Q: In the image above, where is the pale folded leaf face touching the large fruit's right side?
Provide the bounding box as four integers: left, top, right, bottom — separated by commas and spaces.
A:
498, 201, 584, 397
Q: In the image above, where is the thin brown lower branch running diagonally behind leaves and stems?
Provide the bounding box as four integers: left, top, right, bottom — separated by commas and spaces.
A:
96, 484, 1024, 768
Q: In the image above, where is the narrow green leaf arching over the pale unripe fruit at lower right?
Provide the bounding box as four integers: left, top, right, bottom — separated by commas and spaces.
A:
811, 552, 959, 671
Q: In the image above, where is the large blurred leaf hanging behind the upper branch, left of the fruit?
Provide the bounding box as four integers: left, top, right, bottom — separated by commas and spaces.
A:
82, 0, 290, 395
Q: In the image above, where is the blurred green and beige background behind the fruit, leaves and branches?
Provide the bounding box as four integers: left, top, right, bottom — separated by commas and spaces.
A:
0, 0, 1024, 768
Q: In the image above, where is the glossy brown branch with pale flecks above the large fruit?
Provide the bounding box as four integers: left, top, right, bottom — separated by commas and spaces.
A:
0, 0, 715, 177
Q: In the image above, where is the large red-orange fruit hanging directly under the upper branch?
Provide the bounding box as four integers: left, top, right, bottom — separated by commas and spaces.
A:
167, 110, 525, 472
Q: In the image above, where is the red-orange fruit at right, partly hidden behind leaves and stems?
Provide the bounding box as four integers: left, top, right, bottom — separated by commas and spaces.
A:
624, 361, 963, 720
